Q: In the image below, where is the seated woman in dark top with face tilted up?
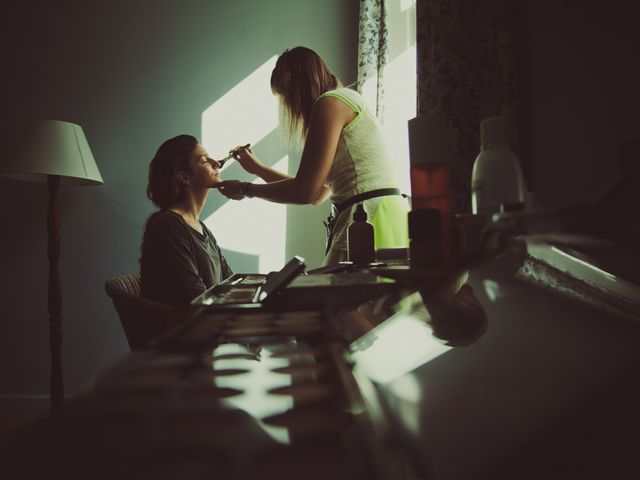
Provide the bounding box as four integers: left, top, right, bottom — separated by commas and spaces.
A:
140, 135, 233, 306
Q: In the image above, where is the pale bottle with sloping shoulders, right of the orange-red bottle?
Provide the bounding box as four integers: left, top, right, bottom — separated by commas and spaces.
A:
471, 117, 526, 214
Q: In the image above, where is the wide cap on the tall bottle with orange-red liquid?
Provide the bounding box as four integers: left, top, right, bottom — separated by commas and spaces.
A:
409, 113, 451, 165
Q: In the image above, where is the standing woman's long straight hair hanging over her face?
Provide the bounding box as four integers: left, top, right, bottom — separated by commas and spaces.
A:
271, 47, 341, 140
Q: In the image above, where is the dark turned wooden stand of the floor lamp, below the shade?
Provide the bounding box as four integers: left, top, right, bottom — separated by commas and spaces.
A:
47, 175, 64, 411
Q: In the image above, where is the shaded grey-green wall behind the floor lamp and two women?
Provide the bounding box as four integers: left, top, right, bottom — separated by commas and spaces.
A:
0, 0, 359, 395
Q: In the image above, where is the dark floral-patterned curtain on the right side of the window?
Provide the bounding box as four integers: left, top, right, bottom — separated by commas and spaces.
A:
417, 0, 519, 212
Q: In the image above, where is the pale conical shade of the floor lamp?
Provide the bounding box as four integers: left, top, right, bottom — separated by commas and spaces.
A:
0, 120, 104, 185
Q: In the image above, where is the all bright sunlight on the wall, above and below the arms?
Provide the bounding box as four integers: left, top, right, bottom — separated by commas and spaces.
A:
202, 55, 289, 273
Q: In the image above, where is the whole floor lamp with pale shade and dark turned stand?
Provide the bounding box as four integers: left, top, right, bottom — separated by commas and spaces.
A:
0, 120, 103, 410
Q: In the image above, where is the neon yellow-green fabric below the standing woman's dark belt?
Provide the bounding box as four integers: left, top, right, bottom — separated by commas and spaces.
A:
369, 195, 409, 249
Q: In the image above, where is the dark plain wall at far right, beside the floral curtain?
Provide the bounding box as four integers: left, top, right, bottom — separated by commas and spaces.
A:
518, 0, 640, 208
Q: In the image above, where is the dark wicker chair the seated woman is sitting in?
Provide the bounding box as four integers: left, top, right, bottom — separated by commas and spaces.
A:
104, 273, 187, 350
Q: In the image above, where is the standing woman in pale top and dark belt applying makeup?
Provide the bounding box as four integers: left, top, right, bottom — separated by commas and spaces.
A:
218, 47, 409, 265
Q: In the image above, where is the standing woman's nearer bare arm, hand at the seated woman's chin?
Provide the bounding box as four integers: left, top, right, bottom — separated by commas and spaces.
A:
219, 97, 356, 204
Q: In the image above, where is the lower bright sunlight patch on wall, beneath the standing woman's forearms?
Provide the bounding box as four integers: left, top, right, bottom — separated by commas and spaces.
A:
204, 156, 289, 273
